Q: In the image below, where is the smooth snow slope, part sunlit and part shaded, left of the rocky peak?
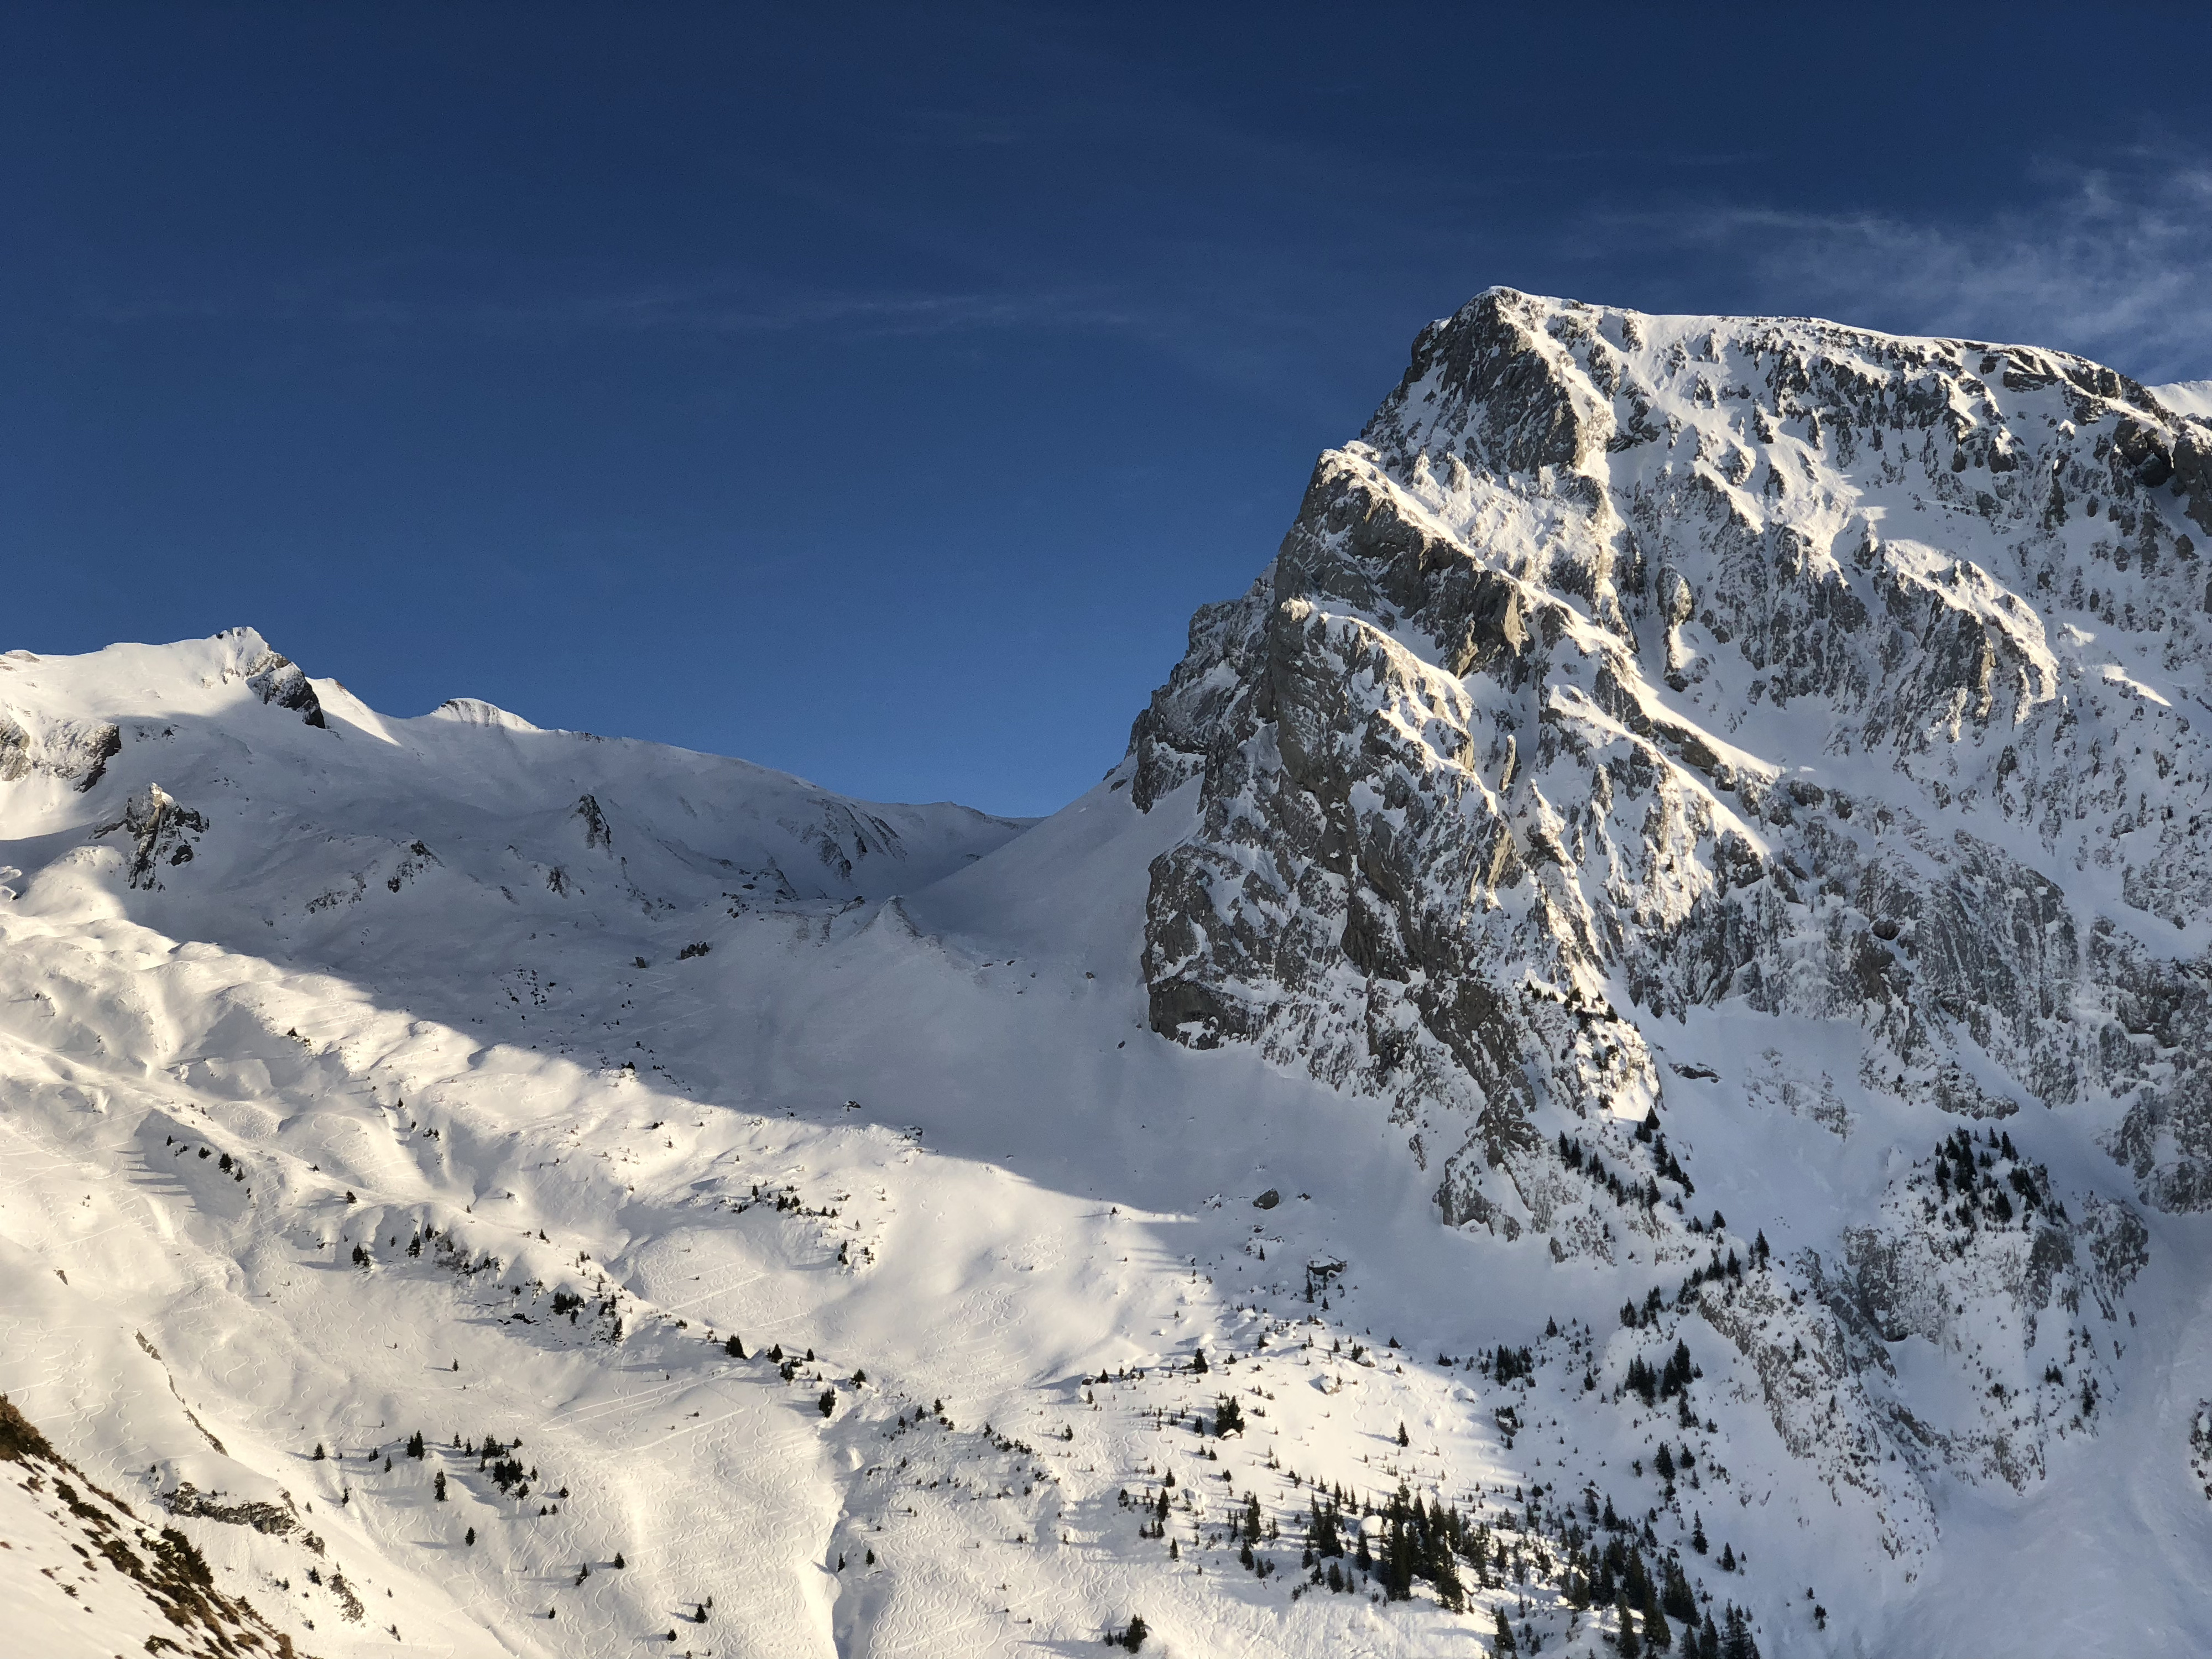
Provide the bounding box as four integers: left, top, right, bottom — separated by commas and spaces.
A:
0, 637, 1575, 1655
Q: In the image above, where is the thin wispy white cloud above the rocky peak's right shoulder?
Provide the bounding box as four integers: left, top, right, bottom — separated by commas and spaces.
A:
1610, 155, 2212, 383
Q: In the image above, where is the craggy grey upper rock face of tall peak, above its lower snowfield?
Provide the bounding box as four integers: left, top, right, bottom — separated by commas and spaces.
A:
1133, 290, 2212, 1230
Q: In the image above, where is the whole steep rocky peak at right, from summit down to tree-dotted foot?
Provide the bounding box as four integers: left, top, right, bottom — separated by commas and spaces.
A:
1133, 290, 2212, 1641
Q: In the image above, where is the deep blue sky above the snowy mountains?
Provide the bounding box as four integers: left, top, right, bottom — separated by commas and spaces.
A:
0, 4, 2212, 812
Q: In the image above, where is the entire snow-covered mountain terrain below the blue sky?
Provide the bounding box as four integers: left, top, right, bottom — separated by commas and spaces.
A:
0, 290, 2212, 1659
